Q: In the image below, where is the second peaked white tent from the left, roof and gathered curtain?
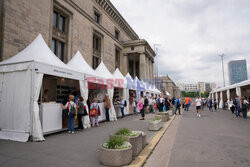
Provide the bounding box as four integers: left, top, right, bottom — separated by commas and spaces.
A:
67, 51, 106, 128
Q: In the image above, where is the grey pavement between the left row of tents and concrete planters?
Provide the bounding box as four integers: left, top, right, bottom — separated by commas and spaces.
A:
0, 114, 157, 167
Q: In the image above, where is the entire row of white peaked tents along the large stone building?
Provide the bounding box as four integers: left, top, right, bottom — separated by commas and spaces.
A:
0, 34, 160, 142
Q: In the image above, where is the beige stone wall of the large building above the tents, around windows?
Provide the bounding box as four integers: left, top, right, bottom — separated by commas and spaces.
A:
0, 0, 134, 72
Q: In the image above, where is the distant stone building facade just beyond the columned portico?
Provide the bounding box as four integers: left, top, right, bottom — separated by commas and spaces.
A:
157, 75, 181, 97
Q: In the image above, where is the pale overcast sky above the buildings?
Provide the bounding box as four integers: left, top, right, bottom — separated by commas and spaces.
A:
111, 0, 250, 86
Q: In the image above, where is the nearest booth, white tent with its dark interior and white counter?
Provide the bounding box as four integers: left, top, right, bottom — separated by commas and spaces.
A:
0, 34, 84, 142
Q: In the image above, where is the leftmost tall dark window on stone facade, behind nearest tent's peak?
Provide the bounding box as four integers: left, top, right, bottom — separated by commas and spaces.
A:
51, 8, 69, 62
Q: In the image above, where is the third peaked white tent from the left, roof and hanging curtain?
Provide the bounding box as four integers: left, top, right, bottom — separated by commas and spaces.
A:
95, 62, 117, 121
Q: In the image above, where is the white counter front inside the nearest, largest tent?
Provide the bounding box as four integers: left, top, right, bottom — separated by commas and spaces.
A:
40, 103, 62, 134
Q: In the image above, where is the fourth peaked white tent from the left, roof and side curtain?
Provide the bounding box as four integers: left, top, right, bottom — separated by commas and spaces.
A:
113, 68, 129, 115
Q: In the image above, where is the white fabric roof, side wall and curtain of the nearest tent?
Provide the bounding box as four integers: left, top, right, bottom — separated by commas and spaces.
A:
0, 34, 83, 142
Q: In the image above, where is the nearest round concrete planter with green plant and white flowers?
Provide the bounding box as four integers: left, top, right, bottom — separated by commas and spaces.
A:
99, 136, 132, 166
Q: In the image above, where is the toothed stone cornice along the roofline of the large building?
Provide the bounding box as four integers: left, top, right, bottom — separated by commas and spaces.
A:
94, 0, 139, 40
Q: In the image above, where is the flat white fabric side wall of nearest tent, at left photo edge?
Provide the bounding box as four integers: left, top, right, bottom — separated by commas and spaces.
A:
0, 70, 31, 142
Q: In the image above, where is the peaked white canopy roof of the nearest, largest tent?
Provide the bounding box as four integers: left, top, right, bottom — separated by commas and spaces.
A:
0, 34, 83, 79
